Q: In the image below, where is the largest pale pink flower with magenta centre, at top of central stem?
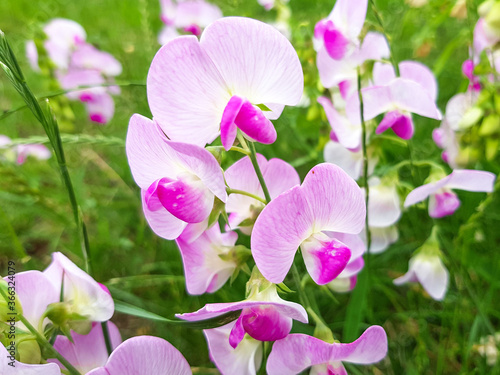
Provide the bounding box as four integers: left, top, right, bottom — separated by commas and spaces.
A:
147, 17, 304, 150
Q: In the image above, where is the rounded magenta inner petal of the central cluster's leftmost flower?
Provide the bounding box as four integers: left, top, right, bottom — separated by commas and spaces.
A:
156, 179, 214, 223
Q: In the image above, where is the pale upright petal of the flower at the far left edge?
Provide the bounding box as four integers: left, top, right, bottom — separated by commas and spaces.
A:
0, 271, 60, 330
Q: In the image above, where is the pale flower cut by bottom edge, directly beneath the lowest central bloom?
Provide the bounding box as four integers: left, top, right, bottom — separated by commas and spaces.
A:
203, 322, 263, 375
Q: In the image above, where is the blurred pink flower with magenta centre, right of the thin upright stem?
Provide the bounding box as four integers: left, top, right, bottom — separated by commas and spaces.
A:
346, 61, 441, 139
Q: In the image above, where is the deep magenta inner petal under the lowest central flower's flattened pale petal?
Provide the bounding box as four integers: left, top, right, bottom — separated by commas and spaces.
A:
239, 306, 292, 341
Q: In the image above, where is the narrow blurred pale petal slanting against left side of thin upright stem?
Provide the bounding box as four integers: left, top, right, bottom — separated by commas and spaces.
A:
318, 96, 361, 149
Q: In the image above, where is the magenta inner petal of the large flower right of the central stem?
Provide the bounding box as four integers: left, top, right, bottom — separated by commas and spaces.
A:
300, 236, 351, 285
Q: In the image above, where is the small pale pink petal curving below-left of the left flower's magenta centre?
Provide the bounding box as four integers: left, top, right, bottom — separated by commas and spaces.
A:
141, 189, 187, 240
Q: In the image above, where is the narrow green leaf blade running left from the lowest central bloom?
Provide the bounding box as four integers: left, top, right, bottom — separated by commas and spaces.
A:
115, 300, 241, 329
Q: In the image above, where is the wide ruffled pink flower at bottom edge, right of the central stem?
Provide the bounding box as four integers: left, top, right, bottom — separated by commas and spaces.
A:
266, 326, 387, 375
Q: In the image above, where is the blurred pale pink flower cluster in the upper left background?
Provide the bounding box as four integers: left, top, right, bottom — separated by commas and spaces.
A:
26, 18, 122, 124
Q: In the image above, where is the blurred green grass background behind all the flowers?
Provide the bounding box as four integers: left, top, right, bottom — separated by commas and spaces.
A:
0, 0, 500, 374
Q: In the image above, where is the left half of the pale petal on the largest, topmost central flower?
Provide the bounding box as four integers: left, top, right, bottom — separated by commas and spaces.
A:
147, 36, 229, 146
